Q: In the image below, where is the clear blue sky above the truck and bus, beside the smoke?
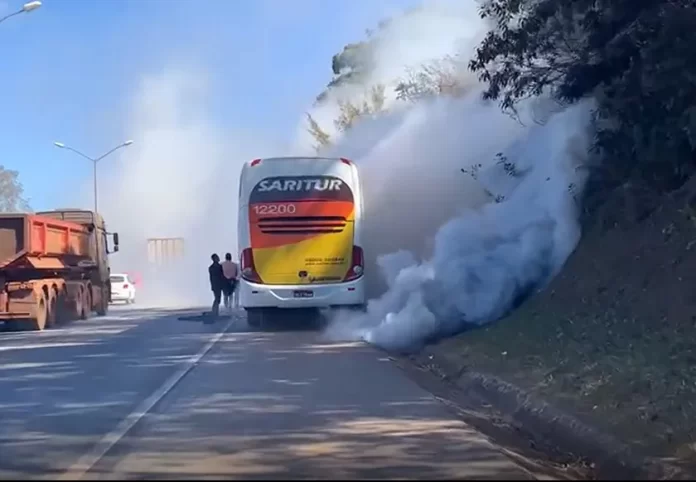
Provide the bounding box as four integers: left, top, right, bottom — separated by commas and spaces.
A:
0, 0, 419, 210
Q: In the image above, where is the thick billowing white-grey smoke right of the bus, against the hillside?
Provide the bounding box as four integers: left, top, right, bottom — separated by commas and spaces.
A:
308, 1, 591, 349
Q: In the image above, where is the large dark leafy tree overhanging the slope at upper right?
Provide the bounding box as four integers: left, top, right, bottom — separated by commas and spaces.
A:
469, 0, 696, 213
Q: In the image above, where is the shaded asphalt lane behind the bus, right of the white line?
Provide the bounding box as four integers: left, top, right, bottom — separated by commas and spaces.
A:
89, 333, 530, 480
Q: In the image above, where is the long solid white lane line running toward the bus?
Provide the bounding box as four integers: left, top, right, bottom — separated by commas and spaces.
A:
58, 319, 234, 480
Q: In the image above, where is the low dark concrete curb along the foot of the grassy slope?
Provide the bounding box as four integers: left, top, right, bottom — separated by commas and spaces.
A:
412, 347, 691, 480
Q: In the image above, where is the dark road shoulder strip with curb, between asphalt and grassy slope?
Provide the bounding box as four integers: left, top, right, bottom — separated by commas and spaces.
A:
393, 347, 681, 480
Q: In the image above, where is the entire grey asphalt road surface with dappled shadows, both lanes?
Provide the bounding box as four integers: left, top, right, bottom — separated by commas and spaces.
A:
0, 308, 533, 480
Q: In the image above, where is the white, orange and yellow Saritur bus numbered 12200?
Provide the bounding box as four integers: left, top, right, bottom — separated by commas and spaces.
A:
237, 157, 365, 326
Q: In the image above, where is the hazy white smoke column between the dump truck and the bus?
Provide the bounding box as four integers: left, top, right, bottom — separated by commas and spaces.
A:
100, 69, 282, 306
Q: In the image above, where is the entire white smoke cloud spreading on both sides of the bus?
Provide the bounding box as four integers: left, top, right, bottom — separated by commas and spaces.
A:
94, 1, 591, 356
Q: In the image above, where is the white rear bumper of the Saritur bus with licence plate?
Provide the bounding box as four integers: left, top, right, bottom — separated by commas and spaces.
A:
237, 277, 365, 308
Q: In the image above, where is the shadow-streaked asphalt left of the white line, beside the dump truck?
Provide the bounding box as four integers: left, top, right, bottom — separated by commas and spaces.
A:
0, 309, 231, 479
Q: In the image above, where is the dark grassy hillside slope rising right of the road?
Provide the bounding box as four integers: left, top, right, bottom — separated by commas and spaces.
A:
431, 179, 696, 466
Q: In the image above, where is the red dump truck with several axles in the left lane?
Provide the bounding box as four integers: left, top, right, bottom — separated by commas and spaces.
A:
0, 209, 118, 330
